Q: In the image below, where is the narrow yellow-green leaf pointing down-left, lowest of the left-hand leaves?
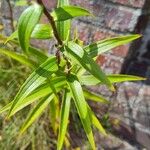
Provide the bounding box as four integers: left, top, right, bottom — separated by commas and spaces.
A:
20, 94, 54, 134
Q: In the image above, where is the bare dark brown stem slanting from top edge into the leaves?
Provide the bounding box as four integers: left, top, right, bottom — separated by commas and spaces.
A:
37, 0, 63, 45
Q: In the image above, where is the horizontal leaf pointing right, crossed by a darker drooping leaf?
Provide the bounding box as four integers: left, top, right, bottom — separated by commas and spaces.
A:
79, 74, 146, 85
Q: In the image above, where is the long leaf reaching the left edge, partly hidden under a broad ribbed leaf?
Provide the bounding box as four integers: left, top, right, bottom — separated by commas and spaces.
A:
0, 76, 66, 115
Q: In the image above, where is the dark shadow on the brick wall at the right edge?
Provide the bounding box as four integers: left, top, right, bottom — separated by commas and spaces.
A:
121, 0, 150, 85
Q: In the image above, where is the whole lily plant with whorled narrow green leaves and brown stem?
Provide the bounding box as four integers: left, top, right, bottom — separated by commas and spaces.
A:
0, 0, 144, 150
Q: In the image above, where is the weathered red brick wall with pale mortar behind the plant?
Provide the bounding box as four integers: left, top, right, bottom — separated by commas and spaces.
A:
2, 0, 150, 149
